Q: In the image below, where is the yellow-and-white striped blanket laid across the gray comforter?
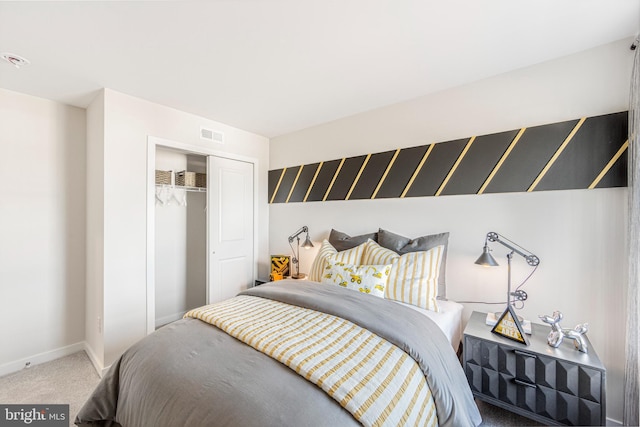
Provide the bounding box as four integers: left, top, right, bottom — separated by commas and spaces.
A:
185, 295, 438, 426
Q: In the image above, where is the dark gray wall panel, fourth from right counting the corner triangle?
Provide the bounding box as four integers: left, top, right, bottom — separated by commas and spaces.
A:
441, 130, 518, 196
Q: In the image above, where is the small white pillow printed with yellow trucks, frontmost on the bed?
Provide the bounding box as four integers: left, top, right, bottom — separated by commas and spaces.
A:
322, 261, 391, 298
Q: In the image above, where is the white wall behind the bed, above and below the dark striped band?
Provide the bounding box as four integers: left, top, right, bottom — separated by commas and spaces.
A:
269, 40, 633, 420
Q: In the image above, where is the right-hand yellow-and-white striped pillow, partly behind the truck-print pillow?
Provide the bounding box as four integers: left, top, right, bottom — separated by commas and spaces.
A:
362, 240, 444, 312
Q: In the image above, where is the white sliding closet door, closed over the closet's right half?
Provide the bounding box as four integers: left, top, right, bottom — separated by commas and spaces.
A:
207, 156, 254, 304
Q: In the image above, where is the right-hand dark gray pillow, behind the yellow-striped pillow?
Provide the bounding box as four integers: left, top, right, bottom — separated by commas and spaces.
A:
378, 229, 449, 299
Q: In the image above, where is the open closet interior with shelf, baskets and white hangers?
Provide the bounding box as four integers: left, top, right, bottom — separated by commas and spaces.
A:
154, 147, 207, 328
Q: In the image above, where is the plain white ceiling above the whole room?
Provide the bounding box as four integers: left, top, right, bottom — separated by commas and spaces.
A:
0, 0, 640, 137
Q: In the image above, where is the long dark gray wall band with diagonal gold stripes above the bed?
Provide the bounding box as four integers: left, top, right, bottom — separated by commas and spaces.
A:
268, 112, 628, 203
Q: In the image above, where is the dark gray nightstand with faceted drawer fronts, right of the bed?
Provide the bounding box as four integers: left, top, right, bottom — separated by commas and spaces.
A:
462, 311, 606, 425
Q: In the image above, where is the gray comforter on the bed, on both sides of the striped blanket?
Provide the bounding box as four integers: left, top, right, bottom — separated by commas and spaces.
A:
75, 280, 481, 427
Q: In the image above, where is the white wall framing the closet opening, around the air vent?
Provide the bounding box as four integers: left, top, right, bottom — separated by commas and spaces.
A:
88, 89, 269, 366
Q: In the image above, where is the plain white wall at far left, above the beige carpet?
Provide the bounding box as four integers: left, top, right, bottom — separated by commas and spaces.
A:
0, 89, 86, 375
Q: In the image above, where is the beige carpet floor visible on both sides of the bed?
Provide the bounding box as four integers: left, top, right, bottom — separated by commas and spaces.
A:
0, 352, 542, 427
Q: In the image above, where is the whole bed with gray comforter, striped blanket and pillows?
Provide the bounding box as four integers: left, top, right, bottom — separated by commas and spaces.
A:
75, 229, 481, 427
